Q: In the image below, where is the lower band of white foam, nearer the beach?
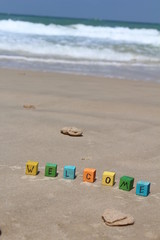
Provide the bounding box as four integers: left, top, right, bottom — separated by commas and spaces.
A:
0, 41, 160, 64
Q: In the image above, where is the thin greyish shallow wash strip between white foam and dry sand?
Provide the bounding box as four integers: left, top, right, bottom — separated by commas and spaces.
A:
0, 61, 160, 83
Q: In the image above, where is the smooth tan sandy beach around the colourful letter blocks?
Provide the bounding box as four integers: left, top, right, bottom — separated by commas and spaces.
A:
0, 69, 160, 240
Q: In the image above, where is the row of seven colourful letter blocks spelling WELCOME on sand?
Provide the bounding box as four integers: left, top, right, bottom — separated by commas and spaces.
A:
26, 161, 150, 196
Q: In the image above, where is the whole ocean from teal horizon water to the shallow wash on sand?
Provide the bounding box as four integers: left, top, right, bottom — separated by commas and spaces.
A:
0, 14, 160, 81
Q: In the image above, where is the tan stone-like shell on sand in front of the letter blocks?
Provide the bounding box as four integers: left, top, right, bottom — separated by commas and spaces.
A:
102, 209, 134, 226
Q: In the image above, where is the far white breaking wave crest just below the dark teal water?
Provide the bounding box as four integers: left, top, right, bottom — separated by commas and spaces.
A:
0, 20, 160, 46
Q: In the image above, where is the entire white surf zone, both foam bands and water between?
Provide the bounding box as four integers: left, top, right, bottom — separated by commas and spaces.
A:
0, 19, 160, 74
